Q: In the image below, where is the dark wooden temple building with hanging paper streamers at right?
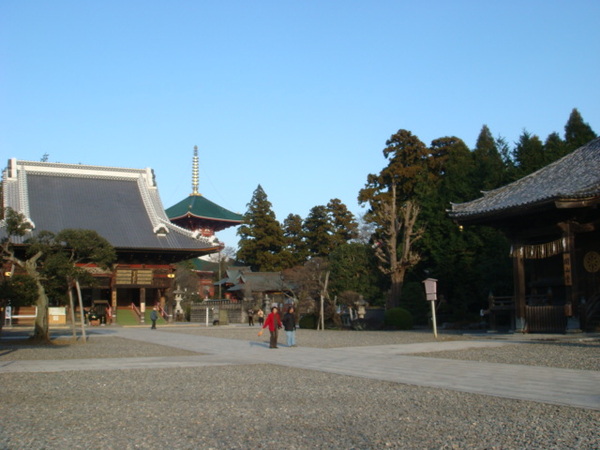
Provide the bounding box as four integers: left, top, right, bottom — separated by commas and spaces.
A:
449, 138, 600, 332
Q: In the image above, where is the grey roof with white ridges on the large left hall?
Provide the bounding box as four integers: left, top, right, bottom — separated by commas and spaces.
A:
3, 159, 217, 253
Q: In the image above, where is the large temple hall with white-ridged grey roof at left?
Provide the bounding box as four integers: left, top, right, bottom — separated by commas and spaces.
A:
2, 158, 221, 319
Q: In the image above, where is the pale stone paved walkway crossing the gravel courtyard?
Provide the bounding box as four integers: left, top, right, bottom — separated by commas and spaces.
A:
0, 328, 600, 410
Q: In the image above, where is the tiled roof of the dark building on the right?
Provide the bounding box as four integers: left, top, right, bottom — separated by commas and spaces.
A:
449, 138, 600, 222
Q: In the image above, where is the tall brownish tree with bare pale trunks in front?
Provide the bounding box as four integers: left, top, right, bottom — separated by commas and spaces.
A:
358, 130, 430, 308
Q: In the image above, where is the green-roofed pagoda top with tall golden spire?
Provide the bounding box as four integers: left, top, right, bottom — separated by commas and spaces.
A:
166, 146, 243, 238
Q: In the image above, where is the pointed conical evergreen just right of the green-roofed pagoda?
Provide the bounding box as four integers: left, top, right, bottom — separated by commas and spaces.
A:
237, 185, 285, 272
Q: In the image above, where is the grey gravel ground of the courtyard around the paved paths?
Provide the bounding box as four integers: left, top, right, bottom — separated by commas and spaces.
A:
0, 327, 600, 449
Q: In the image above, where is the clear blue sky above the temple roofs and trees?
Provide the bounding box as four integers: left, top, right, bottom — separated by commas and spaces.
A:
0, 0, 600, 250
